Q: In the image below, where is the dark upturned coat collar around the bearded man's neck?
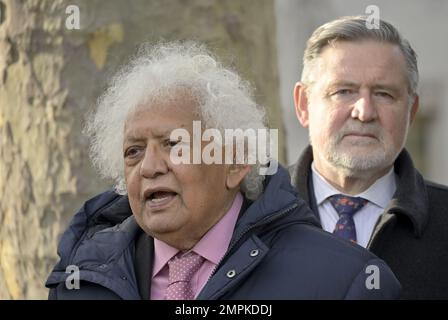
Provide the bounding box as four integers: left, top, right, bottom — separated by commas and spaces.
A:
289, 146, 429, 237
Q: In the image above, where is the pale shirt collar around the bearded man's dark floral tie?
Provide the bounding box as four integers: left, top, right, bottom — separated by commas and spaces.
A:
311, 162, 397, 209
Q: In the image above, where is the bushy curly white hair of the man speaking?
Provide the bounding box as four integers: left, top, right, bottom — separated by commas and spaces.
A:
84, 42, 266, 200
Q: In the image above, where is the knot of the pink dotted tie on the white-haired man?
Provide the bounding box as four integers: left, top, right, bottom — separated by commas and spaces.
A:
168, 251, 204, 284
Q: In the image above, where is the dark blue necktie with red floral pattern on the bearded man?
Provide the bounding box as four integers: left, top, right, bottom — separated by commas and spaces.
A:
328, 194, 368, 243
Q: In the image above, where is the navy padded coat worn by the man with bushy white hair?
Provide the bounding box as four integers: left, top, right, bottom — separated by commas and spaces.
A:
46, 167, 400, 300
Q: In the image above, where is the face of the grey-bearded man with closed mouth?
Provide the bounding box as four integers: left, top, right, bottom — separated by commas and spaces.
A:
295, 41, 418, 174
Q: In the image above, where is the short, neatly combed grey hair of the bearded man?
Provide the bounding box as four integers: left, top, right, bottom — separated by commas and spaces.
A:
301, 16, 419, 95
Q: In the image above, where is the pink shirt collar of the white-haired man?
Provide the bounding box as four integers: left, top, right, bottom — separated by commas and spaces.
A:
152, 192, 243, 277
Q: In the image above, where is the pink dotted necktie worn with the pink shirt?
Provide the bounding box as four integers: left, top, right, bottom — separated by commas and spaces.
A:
166, 251, 204, 300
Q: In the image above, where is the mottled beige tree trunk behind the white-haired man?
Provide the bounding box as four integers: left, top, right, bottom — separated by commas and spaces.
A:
0, 0, 284, 299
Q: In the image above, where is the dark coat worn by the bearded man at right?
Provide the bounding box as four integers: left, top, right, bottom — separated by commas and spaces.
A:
289, 146, 448, 299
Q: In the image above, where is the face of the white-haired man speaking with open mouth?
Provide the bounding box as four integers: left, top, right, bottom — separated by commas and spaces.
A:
123, 99, 242, 250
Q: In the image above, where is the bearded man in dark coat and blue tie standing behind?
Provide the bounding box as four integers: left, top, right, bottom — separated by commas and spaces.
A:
290, 17, 448, 299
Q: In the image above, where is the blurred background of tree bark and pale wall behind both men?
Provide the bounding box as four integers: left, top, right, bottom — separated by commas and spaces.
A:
0, 0, 448, 299
